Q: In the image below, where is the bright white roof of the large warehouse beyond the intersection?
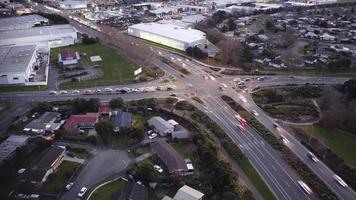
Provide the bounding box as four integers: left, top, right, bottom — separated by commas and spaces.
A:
129, 23, 206, 43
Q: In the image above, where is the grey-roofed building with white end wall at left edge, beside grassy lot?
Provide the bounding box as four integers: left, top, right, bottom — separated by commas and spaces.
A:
0, 45, 37, 85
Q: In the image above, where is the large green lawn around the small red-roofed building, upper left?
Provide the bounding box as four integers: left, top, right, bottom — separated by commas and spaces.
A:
51, 44, 135, 88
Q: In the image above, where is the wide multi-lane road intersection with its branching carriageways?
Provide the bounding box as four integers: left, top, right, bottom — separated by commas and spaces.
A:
0, 3, 356, 200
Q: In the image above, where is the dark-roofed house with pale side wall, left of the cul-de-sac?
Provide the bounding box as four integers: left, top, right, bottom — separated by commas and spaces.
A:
19, 146, 66, 187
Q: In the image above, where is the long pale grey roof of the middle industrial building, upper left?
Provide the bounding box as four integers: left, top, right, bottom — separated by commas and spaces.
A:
0, 24, 77, 44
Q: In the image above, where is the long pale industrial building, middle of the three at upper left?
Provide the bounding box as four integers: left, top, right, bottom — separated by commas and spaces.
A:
0, 24, 78, 48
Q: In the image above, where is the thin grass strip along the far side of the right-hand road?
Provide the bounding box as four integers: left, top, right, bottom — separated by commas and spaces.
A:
261, 69, 356, 78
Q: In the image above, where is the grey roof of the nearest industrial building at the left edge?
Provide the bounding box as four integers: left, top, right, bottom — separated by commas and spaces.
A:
0, 44, 36, 74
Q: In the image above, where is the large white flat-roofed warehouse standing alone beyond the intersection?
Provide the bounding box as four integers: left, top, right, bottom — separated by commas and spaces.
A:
127, 23, 206, 51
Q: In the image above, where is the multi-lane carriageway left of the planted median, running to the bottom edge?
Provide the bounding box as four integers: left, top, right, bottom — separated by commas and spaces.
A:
204, 97, 317, 199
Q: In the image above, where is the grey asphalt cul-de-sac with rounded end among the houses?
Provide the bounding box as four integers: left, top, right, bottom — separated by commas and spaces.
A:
61, 149, 130, 200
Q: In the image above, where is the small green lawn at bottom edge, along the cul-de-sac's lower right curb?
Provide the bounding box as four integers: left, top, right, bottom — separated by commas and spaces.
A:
90, 179, 127, 200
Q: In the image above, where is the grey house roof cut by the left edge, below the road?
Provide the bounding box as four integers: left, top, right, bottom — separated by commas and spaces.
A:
0, 135, 29, 163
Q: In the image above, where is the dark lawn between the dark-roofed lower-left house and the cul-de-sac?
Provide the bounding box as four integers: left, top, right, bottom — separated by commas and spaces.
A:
40, 160, 80, 194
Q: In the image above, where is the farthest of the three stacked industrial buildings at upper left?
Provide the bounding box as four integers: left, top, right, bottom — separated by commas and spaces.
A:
0, 15, 48, 31
